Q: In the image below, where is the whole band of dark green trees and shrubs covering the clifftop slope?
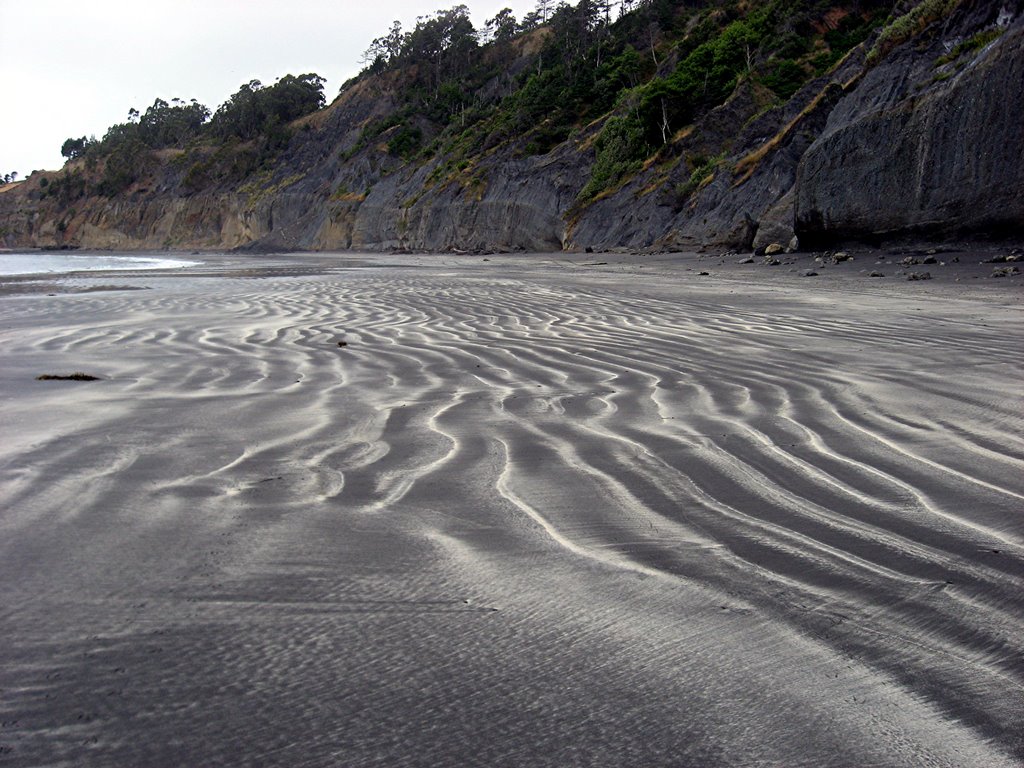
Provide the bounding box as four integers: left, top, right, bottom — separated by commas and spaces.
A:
54, 0, 913, 206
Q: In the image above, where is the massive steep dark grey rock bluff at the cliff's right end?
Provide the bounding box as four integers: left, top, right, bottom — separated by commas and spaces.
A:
796, 3, 1024, 245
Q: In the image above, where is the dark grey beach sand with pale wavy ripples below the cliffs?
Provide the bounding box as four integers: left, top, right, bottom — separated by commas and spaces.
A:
0, 252, 1024, 767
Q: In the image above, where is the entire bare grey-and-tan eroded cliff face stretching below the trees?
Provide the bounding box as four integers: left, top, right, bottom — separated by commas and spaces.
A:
0, 0, 1024, 251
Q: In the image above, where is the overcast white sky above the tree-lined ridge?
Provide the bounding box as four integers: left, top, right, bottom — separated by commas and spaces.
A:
0, 0, 536, 178
